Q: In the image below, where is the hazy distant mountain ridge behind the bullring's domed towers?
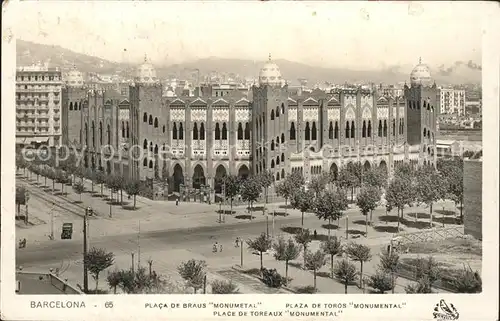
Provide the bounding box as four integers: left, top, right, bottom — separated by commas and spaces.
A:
17, 40, 481, 84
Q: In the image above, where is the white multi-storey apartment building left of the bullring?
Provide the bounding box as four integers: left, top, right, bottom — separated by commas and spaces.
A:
16, 64, 63, 146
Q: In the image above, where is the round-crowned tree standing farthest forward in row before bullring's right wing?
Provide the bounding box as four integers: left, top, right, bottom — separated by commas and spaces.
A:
314, 189, 348, 237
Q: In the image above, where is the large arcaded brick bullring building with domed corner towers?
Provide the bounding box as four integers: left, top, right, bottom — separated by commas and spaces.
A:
62, 55, 439, 198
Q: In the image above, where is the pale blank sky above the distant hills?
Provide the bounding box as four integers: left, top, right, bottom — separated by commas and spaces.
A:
5, 1, 488, 70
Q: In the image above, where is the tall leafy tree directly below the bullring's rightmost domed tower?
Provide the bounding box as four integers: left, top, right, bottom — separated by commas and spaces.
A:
417, 166, 446, 228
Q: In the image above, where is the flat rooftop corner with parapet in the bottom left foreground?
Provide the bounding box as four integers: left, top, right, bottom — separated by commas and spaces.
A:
16, 271, 82, 295
